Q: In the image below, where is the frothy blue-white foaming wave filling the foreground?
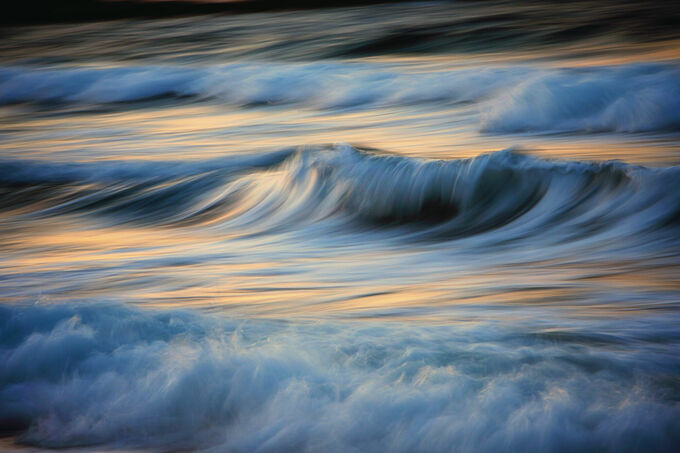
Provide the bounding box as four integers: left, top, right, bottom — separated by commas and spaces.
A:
0, 303, 680, 452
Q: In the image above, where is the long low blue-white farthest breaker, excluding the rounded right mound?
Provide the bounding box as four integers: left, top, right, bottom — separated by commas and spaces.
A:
0, 62, 526, 108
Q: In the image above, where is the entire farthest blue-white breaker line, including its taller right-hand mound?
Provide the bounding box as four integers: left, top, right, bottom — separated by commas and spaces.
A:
0, 62, 680, 133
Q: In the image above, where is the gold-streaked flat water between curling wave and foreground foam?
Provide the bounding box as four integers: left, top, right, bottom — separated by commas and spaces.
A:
0, 214, 680, 322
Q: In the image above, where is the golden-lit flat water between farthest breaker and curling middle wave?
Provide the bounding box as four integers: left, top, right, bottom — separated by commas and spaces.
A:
0, 103, 680, 166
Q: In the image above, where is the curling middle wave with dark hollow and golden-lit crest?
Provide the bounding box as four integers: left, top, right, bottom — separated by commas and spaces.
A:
0, 144, 680, 240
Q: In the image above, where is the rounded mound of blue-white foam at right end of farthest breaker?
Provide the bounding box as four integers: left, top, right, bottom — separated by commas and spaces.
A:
482, 65, 680, 133
